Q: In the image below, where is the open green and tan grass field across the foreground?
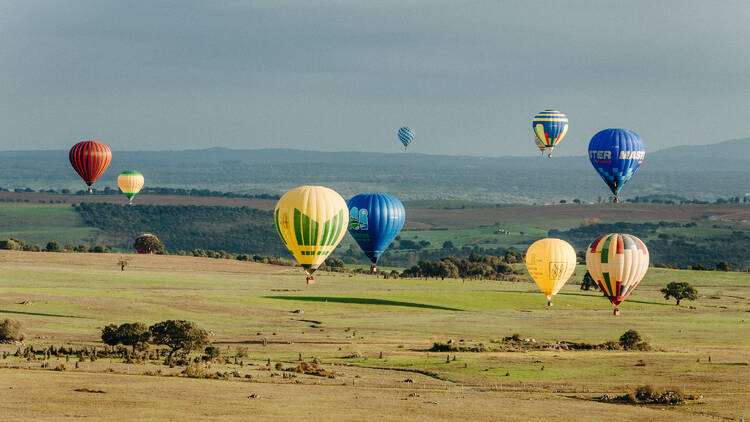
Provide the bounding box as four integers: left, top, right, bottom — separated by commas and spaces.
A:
0, 251, 750, 420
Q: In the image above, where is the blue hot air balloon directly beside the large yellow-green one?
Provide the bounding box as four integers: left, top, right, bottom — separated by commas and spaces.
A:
347, 193, 406, 272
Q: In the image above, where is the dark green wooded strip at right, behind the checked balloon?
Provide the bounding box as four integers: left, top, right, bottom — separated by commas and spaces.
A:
549, 221, 750, 270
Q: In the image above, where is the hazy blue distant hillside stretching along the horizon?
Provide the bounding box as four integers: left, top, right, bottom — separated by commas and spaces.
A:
0, 139, 750, 203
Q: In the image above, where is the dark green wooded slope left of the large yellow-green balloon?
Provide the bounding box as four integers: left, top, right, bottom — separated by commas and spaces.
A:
75, 203, 291, 257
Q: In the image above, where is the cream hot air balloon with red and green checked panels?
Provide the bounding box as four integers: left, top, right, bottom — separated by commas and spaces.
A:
586, 233, 648, 315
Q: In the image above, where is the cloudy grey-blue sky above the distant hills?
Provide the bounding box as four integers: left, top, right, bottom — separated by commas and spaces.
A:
0, 0, 750, 156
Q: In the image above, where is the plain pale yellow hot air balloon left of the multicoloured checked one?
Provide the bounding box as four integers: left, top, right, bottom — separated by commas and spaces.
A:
526, 238, 576, 306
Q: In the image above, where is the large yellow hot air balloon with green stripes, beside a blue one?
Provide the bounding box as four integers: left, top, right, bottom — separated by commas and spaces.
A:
274, 186, 347, 284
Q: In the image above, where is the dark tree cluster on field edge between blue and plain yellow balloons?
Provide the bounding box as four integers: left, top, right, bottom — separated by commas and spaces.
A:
401, 254, 519, 280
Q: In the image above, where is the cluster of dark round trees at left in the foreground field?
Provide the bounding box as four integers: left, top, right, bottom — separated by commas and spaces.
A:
101, 320, 211, 364
